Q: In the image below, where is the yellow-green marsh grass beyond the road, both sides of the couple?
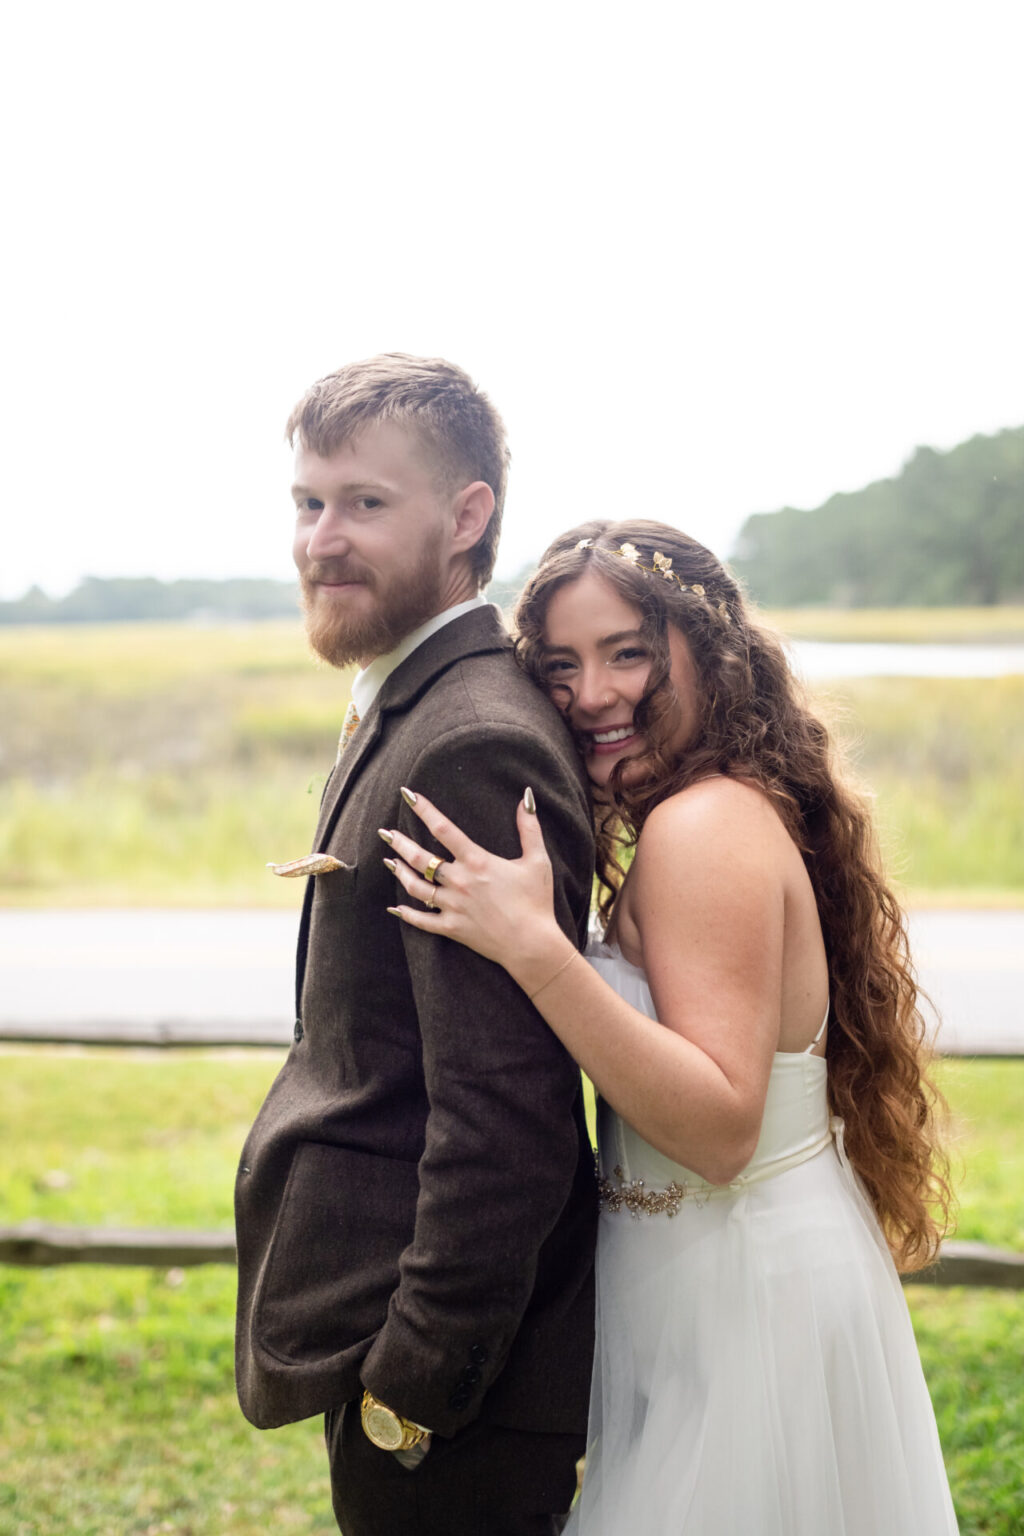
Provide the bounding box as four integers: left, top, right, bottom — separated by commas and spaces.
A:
0, 608, 1024, 906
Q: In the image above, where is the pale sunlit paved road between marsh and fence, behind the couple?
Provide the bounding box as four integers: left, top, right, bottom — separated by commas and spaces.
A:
0, 909, 1024, 1054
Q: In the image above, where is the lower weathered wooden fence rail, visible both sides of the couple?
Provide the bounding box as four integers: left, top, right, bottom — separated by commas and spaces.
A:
0, 1221, 1024, 1290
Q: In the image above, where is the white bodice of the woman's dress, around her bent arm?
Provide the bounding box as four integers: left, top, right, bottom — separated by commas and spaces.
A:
586, 943, 834, 1193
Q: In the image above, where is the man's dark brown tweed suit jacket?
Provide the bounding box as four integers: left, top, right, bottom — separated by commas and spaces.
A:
235, 608, 596, 1435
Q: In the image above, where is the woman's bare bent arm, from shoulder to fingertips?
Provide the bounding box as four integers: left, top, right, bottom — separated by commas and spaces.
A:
391, 779, 785, 1183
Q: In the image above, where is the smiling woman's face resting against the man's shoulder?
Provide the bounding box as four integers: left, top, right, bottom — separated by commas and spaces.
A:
543, 570, 699, 790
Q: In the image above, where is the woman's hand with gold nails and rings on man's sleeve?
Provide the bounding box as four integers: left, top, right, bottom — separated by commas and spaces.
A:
381, 790, 576, 995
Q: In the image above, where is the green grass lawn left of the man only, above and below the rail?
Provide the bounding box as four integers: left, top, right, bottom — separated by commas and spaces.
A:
0, 1049, 336, 1536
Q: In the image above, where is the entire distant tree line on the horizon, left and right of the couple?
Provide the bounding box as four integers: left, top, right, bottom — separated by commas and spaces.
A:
0, 427, 1024, 624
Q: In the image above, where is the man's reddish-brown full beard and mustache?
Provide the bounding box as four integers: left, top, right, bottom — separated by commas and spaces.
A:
301, 538, 442, 667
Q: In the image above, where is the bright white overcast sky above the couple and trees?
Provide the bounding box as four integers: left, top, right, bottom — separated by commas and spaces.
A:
0, 0, 1024, 596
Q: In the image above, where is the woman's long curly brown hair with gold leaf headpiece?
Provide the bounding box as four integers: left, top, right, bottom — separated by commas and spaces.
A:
516, 519, 953, 1272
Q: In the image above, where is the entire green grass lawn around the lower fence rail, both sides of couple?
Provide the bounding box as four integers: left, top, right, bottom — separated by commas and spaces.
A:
0, 1048, 1024, 1536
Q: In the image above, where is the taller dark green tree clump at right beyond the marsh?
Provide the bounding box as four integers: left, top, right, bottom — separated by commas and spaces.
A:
729, 427, 1024, 608
